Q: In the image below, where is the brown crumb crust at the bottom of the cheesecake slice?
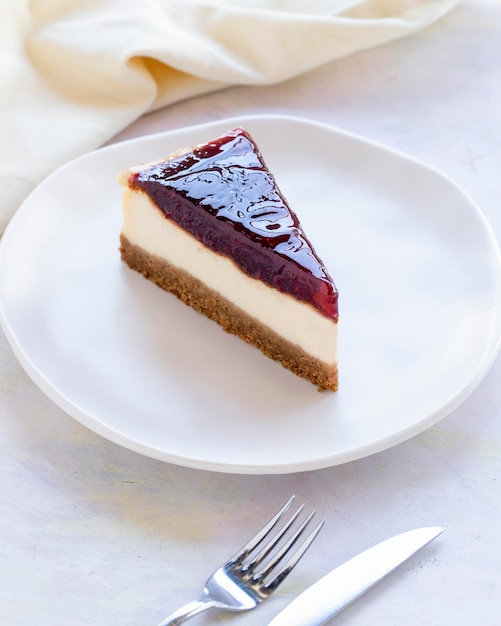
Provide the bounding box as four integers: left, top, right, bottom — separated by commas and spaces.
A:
120, 234, 338, 391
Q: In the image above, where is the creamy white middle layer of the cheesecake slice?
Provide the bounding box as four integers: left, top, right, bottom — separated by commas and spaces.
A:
122, 187, 337, 364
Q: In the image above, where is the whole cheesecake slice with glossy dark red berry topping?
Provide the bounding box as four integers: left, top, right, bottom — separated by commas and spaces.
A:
119, 128, 338, 391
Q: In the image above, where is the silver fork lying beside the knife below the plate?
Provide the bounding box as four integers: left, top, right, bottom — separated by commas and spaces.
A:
158, 496, 324, 626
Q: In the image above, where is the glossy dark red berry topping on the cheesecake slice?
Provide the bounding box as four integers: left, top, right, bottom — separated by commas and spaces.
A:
130, 128, 338, 319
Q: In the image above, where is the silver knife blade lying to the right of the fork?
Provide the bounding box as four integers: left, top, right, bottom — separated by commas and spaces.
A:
268, 526, 443, 626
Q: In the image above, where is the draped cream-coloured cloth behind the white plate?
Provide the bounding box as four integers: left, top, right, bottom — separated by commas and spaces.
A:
0, 0, 458, 233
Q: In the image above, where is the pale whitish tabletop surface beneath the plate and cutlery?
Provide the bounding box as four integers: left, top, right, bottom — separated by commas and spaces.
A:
0, 2, 501, 626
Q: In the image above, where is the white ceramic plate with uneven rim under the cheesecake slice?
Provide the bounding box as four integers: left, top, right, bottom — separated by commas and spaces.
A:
0, 116, 501, 474
